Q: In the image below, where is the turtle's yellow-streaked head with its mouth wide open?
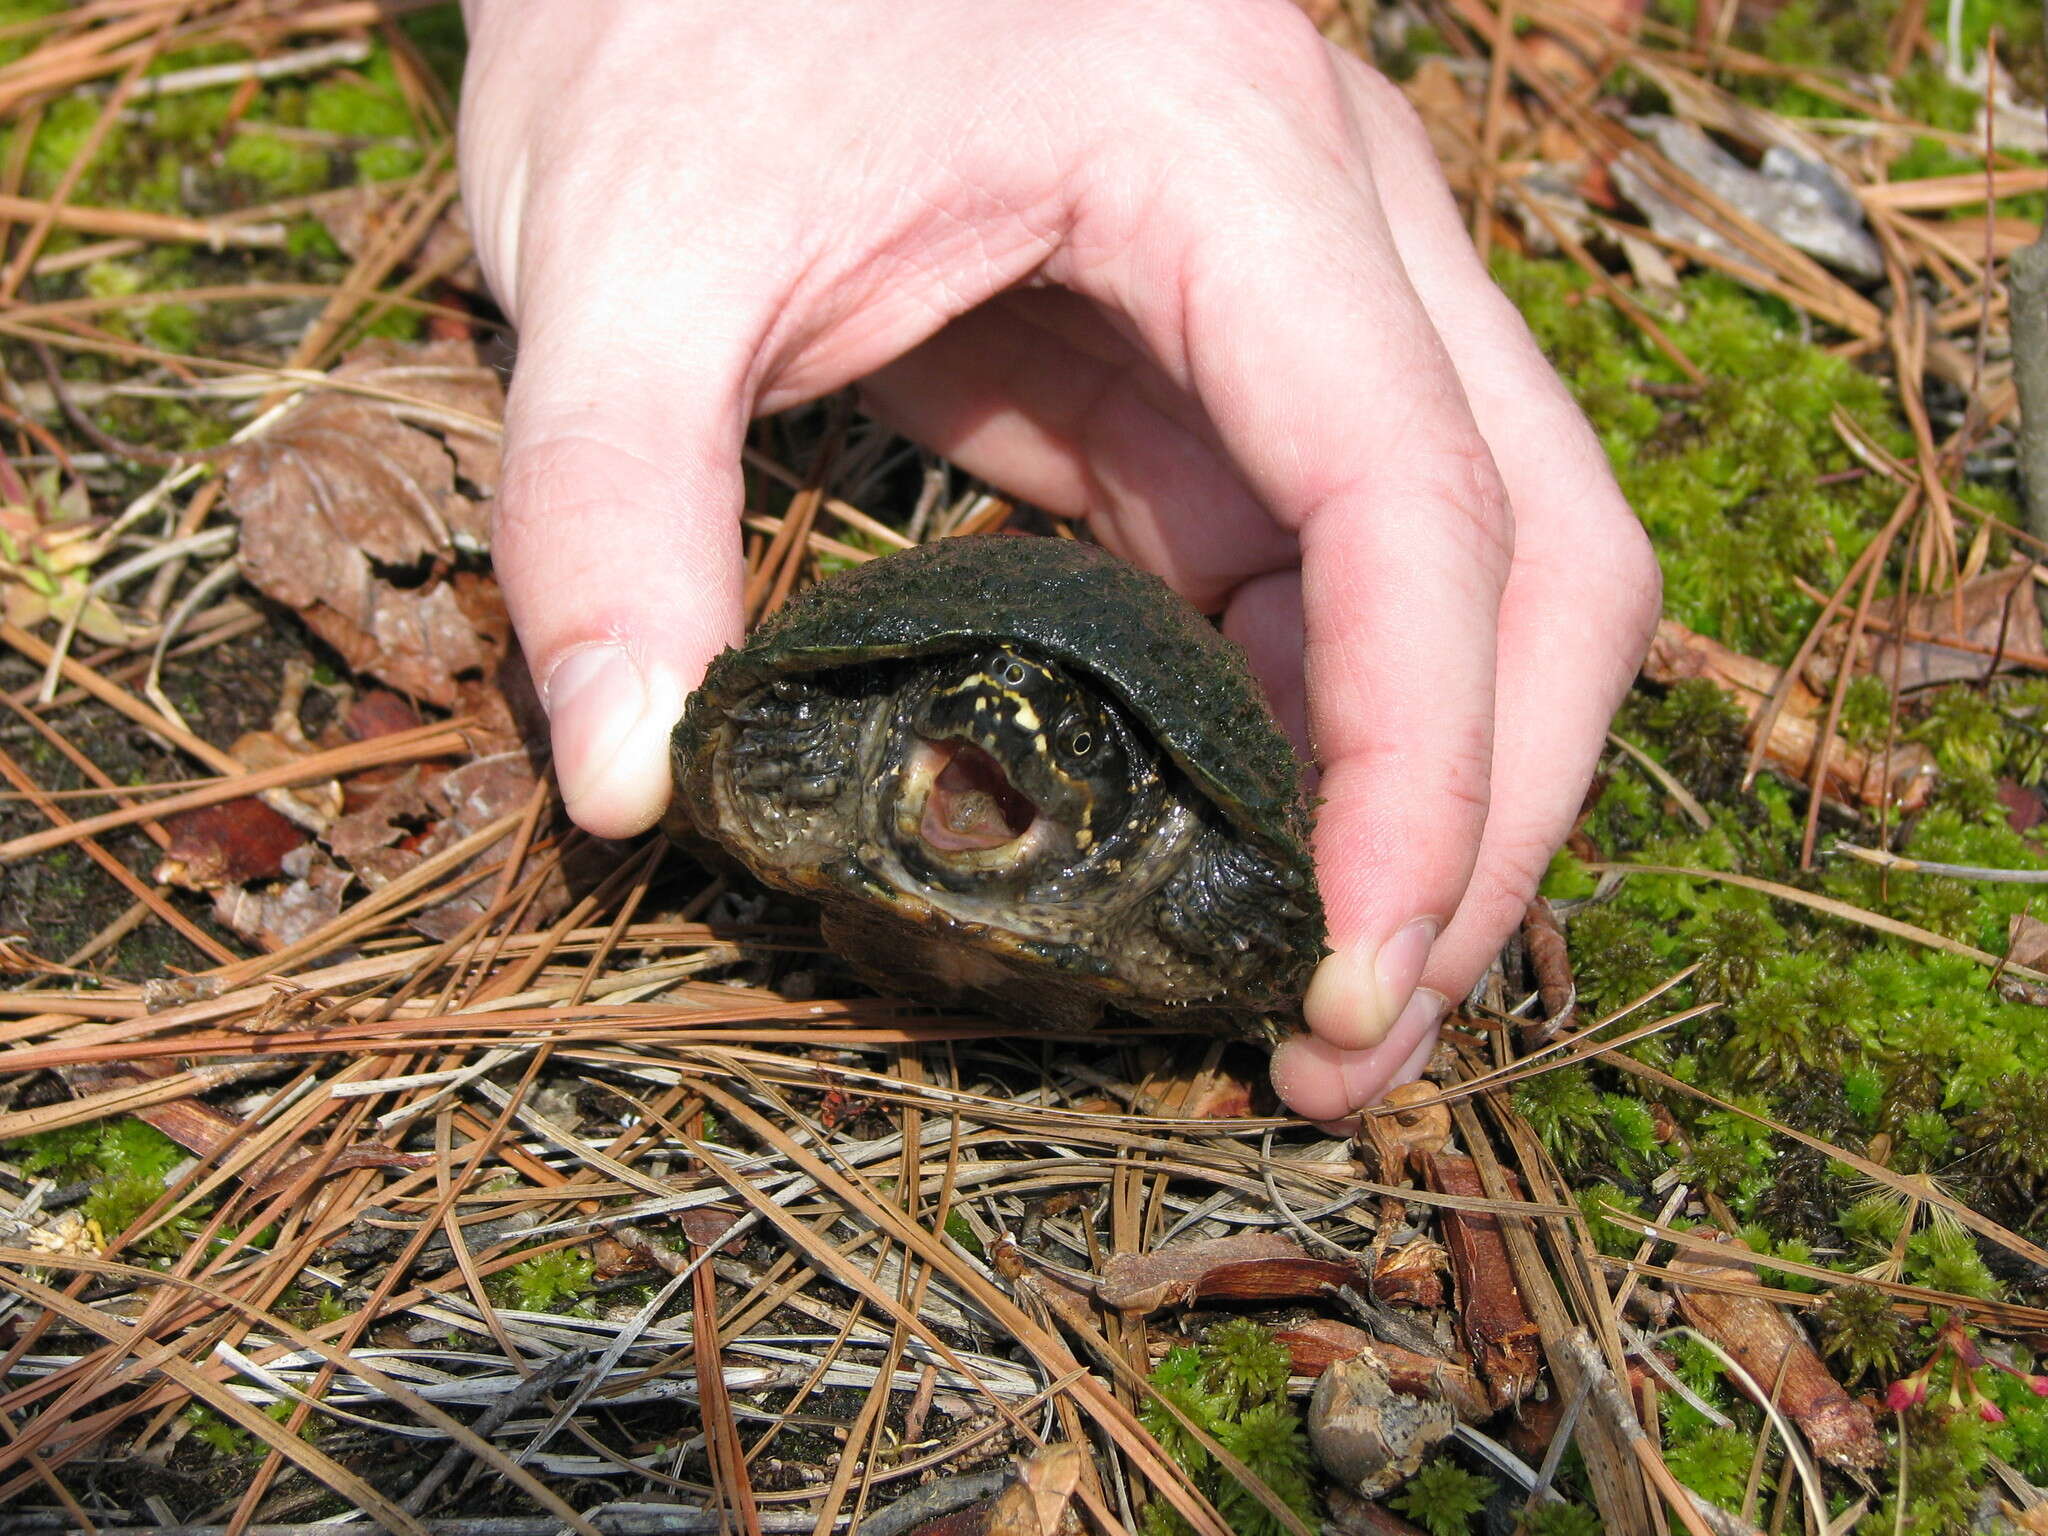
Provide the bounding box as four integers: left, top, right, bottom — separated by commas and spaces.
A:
905, 645, 1135, 868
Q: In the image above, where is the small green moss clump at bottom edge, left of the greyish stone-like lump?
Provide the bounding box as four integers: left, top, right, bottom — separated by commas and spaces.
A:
1139, 1319, 1321, 1536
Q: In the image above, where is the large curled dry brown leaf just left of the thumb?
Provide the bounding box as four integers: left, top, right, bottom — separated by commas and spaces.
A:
225, 342, 510, 709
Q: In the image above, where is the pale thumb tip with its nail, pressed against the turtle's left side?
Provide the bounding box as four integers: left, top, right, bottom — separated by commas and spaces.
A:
541, 645, 682, 838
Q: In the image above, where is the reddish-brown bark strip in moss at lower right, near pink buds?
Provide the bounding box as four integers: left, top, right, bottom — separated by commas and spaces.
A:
1667, 1239, 1884, 1466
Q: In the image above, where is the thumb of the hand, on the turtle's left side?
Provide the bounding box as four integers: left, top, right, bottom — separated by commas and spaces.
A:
492, 328, 745, 838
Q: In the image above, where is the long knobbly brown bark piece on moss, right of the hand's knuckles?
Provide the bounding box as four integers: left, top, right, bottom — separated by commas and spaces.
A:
1642, 618, 1935, 811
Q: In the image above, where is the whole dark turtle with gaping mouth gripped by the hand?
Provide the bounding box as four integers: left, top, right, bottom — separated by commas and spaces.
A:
672, 537, 1323, 1038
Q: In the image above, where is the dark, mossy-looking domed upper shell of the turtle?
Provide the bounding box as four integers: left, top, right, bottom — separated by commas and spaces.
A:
690, 535, 1309, 864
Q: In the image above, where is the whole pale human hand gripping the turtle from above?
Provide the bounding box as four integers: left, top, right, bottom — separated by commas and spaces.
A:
461, 0, 1657, 1120
